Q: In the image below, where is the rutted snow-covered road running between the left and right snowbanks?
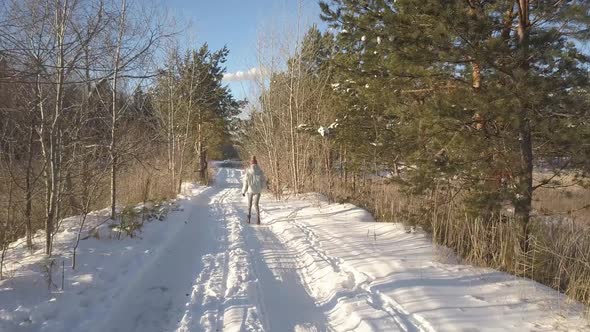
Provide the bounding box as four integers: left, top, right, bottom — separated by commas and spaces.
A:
94, 168, 328, 332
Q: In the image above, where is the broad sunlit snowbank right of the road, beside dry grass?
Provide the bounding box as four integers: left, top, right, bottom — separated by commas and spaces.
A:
264, 197, 590, 331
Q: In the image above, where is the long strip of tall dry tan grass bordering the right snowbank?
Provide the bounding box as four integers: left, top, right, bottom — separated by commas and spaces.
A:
309, 171, 590, 312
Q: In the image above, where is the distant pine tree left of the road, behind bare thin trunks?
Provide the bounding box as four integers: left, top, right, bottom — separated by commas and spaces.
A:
152, 44, 244, 190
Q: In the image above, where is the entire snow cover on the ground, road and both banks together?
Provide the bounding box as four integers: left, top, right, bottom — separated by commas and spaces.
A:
0, 168, 590, 332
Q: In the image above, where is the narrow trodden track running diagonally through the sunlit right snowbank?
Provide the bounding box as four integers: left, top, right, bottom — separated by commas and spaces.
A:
291, 217, 435, 332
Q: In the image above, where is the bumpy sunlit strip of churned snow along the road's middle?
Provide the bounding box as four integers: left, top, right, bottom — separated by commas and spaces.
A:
177, 169, 264, 332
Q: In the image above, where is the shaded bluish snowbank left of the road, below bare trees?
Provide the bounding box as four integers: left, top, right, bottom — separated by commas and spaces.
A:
0, 186, 204, 332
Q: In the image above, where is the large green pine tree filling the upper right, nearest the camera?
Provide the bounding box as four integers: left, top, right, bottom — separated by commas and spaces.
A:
320, 0, 590, 244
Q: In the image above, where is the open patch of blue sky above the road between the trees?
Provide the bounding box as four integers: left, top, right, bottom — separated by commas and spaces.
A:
160, 0, 322, 98
